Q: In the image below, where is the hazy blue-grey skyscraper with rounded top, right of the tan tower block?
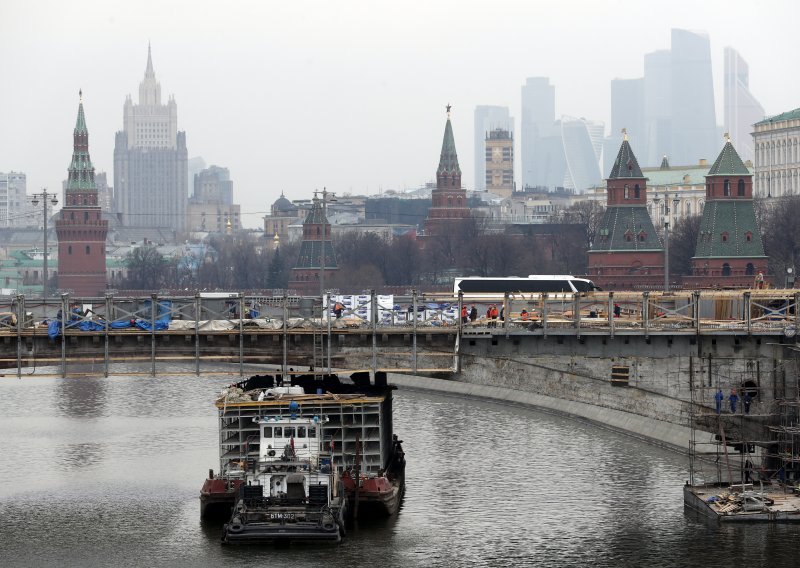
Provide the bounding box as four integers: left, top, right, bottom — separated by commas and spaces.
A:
519, 77, 563, 187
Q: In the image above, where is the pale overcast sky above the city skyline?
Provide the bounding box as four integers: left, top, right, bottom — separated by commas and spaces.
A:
0, 0, 800, 227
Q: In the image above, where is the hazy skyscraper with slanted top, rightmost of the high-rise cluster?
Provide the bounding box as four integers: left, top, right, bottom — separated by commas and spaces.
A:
724, 47, 764, 162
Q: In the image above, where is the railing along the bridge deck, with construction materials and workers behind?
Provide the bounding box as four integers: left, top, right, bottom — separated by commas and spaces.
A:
0, 290, 800, 335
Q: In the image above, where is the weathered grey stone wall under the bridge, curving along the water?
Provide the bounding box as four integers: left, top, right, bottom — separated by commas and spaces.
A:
393, 335, 797, 451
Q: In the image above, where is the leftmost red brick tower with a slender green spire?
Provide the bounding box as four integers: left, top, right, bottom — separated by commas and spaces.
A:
56, 91, 108, 296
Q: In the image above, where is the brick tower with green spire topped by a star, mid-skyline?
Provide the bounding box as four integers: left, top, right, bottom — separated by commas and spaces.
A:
425, 105, 469, 237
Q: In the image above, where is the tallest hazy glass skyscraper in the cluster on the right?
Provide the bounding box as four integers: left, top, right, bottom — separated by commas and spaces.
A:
668, 29, 719, 165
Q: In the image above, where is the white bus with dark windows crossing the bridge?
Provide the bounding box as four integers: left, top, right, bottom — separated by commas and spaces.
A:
453, 274, 600, 296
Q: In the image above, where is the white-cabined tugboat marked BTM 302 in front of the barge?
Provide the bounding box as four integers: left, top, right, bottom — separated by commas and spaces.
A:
222, 414, 347, 544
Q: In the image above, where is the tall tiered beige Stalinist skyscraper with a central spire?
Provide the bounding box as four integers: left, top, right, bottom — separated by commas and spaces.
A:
114, 46, 189, 231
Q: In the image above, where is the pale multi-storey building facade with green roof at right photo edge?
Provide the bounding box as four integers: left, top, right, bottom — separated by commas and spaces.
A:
753, 108, 800, 197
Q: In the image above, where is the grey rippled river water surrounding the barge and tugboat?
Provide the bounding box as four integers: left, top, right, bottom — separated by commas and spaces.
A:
0, 370, 800, 568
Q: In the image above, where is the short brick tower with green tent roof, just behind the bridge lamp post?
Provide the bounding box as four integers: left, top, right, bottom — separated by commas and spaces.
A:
289, 192, 339, 296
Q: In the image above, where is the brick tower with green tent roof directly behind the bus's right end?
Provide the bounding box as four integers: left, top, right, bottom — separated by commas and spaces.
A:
589, 134, 664, 290
